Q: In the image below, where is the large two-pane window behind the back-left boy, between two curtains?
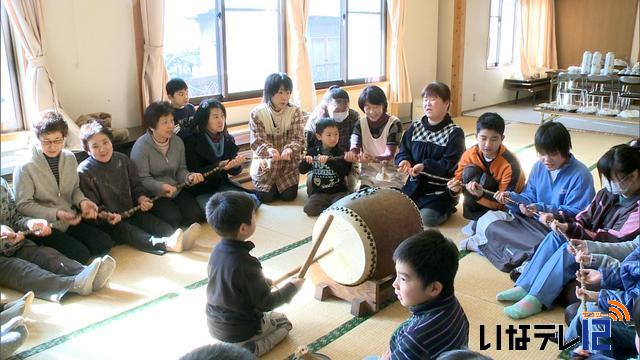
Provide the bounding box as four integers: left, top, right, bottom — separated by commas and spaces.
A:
164, 0, 284, 99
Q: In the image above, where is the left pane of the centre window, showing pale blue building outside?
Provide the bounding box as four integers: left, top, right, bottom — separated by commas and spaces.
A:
307, 0, 342, 82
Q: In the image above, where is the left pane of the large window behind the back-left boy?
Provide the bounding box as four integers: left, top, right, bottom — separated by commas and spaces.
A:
164, 0, 221, 96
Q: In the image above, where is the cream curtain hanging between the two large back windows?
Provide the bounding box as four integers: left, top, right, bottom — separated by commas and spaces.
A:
286, 0, 316, 112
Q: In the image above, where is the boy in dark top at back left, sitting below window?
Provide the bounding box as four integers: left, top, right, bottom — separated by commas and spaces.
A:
165, 78, 198, 140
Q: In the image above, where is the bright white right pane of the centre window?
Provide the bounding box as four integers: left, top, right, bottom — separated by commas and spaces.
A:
347, 13, 384, 79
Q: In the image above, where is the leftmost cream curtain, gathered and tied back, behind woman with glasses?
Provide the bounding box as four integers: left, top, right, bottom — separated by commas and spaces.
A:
3, 0, 81, 150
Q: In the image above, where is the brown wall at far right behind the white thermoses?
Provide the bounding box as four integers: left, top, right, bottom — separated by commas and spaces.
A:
555, 0, 638, 69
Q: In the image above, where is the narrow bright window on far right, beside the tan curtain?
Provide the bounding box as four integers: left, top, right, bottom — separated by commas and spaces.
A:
487, 0, 516, 67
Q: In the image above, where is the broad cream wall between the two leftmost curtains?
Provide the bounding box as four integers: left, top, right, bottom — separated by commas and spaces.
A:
42, 0, 140, 127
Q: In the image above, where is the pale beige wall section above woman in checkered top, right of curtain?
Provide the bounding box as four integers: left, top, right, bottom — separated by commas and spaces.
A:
404, 0, 438, 119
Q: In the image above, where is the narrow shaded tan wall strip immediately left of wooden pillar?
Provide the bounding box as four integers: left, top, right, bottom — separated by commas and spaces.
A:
436, 0, 454, 85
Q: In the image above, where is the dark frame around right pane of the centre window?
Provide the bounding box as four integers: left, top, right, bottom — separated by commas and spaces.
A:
314, 0, 388, 90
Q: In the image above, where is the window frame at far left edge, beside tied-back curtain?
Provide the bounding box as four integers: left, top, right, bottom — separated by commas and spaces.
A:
0, 3, 29, 134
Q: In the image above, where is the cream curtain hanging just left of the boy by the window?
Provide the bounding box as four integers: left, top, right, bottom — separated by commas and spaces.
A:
140, 0, 169, 108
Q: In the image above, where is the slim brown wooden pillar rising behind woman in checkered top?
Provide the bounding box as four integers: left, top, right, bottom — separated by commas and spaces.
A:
449, 0, 467, 117
